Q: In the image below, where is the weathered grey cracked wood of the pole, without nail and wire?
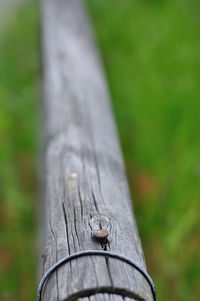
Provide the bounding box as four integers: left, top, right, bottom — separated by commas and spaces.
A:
42, 0, 153, 301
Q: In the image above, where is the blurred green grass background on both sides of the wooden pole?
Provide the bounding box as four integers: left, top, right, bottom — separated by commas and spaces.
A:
0, 0, 200, 301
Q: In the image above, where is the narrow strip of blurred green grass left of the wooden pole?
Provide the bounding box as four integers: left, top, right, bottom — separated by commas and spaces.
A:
0, 3, 38, 301
